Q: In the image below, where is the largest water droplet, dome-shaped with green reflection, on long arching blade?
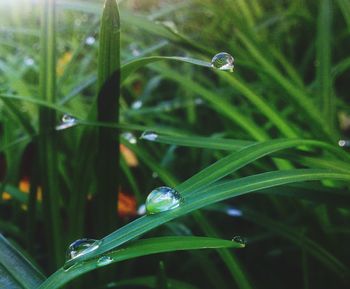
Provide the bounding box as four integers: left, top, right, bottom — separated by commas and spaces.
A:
146, 187, 182, 214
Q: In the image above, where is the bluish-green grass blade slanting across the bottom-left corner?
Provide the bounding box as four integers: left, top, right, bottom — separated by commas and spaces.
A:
0, 234, 45, 289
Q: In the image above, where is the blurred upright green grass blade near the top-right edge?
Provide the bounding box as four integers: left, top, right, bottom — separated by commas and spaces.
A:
316, 0, 336, 130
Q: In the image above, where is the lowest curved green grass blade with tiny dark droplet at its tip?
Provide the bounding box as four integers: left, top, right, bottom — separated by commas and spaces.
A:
39, 236, 244, 289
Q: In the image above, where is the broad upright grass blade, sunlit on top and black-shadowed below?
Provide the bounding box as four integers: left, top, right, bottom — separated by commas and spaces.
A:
94, 0, 120, 235
